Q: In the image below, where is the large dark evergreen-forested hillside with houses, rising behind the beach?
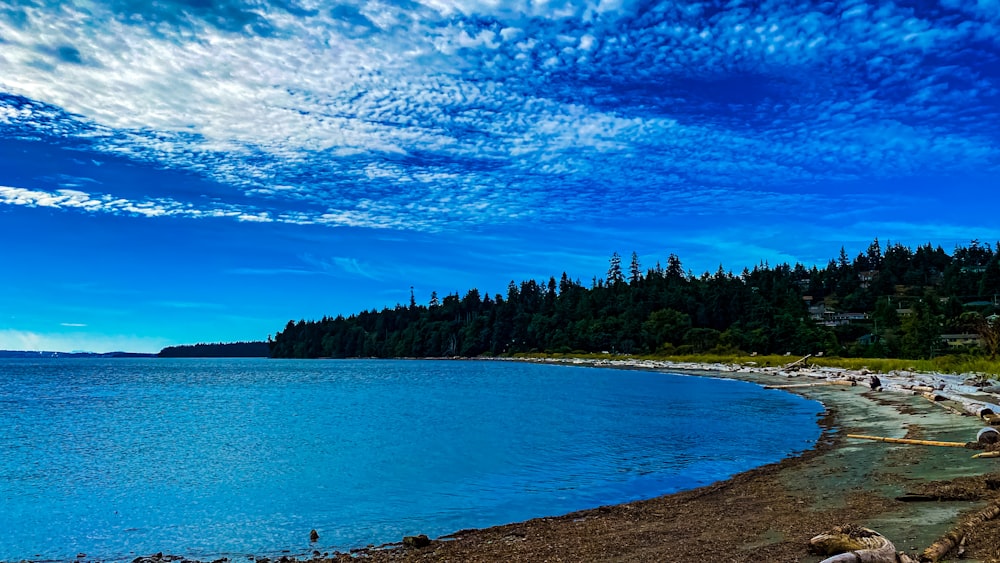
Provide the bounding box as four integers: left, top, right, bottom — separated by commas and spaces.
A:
270, 239, 1000, 358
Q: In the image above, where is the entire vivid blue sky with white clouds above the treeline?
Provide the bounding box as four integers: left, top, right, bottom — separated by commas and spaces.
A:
0, 0, 1000, 351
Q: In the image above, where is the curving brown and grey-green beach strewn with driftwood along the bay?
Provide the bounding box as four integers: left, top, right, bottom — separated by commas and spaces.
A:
7, 359, 1000, 563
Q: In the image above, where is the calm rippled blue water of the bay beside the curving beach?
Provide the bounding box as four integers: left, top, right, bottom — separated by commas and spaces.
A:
0, 360, 822, 560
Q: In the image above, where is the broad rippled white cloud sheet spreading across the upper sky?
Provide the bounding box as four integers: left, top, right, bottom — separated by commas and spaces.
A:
0, 0, 1000, 230
